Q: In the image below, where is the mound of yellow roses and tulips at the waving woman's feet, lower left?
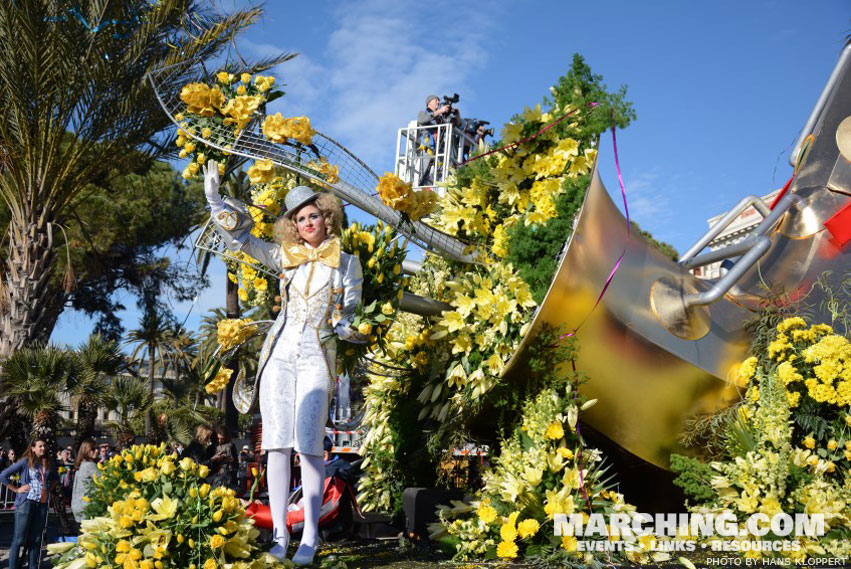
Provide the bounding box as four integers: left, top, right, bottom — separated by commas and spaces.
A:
48, 445, 275, 569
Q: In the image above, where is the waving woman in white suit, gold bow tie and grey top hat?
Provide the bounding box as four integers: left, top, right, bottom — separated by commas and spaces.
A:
204, 161, 363, 565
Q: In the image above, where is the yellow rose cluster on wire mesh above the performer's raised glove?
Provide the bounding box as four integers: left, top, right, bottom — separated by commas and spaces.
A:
175, 71, 283, 179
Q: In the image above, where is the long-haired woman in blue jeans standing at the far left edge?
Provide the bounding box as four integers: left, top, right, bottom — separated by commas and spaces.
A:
0, 439, 57, 569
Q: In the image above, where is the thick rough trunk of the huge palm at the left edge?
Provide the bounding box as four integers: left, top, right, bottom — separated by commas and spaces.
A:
0, 218, 58, 360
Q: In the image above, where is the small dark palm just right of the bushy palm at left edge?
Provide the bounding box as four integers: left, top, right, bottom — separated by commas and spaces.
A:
74, 334, 125, 445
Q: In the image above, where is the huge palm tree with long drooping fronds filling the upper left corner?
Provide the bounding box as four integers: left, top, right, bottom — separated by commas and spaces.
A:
0, 0, 292, 359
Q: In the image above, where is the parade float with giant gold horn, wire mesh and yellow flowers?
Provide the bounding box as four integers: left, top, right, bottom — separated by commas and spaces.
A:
48, 34, 851, 567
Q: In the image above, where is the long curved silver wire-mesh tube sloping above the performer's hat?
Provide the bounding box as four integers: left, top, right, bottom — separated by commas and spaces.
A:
148, 63, 476, 263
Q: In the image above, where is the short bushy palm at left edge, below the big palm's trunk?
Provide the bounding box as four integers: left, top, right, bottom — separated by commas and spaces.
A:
2, 346, 81, 456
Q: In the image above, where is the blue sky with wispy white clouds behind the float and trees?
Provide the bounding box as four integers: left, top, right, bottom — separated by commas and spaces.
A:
52, 0, 851, 345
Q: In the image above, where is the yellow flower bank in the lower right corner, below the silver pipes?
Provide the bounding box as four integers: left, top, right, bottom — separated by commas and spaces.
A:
680, 317, 851, 564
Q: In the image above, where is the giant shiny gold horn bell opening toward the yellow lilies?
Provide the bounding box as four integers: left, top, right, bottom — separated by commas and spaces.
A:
504, 165, 750, 468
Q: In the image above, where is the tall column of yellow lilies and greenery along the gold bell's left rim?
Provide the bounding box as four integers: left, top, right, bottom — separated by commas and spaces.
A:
352, 58, 632, 521
